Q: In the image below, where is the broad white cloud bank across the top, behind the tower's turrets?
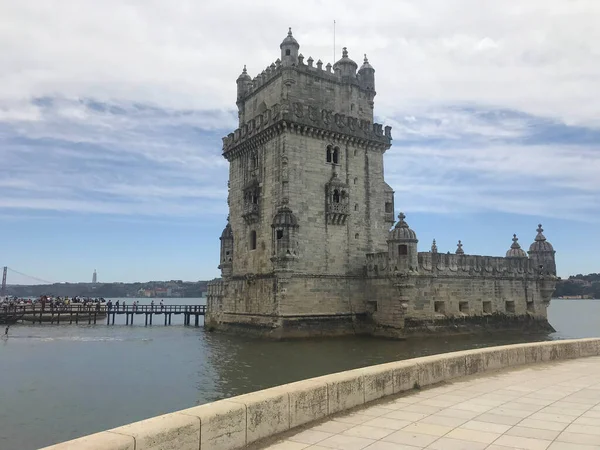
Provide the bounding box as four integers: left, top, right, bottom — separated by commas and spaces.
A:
0, 0, 600, 125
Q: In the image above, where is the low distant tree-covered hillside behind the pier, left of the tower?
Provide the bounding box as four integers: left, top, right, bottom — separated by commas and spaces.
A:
7, 280, 216, 298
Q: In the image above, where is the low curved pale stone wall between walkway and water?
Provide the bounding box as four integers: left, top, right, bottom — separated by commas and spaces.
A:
44, 339, 600, 450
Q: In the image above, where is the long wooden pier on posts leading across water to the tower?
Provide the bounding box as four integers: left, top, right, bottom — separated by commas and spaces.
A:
0, 303, 206, 327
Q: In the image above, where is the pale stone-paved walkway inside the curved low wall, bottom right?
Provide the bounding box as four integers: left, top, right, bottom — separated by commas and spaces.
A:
264, 357, 600, 450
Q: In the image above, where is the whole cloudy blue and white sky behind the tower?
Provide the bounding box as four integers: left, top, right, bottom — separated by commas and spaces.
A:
0, 0, 600, 284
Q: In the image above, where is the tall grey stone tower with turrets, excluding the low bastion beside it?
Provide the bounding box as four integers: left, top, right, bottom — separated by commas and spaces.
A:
207, 29, 396, 335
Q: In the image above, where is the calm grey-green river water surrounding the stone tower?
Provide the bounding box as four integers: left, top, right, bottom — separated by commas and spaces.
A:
0, 299, 600, 450
